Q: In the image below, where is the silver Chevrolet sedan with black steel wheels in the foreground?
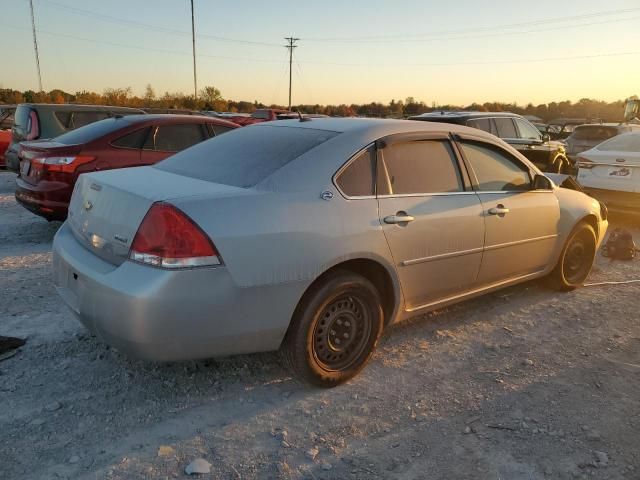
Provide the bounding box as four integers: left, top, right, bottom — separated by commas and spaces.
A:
53, 118, 607, 387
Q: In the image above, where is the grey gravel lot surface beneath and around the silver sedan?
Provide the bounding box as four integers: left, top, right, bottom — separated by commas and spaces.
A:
0, 173, 640, 480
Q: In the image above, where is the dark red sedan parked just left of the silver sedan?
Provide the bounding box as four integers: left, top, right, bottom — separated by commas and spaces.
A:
15, 114, 237, 220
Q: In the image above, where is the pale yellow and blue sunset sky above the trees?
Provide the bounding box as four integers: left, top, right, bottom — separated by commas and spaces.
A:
0, 0, 640, 104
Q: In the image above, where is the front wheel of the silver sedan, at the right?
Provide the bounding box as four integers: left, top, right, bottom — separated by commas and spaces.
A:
548, 222, 597, 291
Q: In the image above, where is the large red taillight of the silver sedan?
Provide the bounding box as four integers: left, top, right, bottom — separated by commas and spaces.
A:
129, 202, 220, 268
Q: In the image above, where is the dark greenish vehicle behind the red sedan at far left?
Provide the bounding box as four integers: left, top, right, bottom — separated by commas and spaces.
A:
5, 103, 144, 173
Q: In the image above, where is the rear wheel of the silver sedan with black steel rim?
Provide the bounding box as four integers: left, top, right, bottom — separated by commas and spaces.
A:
281, 271, 384, 388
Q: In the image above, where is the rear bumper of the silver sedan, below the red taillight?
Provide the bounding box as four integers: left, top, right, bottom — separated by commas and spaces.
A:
53, 223, 304, 361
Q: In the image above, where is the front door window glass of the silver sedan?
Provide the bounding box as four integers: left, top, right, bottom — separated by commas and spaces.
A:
461, 141, 531, 192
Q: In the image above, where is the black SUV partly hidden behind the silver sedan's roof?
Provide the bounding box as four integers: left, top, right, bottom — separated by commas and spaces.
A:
410, 111, 572, 173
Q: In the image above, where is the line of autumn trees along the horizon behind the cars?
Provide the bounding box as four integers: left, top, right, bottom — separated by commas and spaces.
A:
0, 85, 624, 122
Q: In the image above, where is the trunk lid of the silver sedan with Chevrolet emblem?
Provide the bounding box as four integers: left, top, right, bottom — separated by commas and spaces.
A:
68, 167, 245, 265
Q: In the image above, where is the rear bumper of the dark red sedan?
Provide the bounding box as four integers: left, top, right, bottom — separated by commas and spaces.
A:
15, 177, 73, 220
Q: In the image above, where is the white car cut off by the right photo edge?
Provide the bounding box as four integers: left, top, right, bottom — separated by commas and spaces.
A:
578, 131, 640, 213
